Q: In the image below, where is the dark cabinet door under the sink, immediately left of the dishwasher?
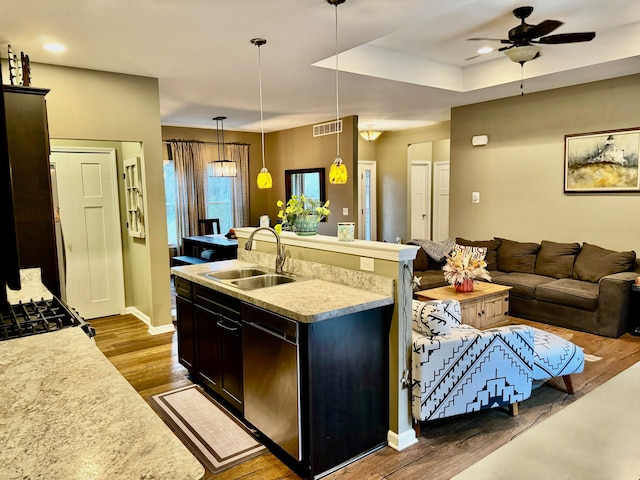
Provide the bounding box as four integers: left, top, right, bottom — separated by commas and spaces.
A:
216, 316, 242, 411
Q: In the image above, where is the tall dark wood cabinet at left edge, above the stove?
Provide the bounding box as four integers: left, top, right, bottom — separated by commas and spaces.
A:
4, 85, 60, 296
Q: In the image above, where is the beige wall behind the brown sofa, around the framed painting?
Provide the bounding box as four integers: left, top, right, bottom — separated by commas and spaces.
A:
450, 75, 640, 252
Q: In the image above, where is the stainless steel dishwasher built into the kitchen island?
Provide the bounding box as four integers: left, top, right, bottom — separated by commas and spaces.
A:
242, 304, 302, 461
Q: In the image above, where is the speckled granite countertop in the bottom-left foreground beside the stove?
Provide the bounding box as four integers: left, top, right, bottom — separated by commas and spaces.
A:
0, 328, 204, 480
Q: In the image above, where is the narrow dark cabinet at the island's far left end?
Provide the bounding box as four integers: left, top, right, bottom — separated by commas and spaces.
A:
174, 277, 195, 375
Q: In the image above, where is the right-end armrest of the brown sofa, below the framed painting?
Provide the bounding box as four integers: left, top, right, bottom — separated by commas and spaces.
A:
597, 272, 637, 338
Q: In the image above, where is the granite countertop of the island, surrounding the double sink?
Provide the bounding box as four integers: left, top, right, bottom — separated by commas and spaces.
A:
171, 260, 394, 323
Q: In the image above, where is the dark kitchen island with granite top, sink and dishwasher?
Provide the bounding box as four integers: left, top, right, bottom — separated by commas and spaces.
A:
172, 252, 394, 479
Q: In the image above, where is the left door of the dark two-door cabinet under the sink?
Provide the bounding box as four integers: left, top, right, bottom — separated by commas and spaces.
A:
193, 305, 222, 393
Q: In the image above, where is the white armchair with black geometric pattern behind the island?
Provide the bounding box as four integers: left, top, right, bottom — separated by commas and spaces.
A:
412, 300, 534, 426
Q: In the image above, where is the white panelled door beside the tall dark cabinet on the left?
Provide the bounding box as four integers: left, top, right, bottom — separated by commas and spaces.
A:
51, 149, 124, 319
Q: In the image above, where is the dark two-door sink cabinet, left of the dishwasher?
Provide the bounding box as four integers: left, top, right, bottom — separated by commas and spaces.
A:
193, 284, 243, 413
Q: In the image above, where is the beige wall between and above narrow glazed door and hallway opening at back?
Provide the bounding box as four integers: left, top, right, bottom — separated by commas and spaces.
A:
358, 122, 451, 242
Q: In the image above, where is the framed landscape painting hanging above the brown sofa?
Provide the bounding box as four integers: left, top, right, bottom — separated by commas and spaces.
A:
564, 128, 640, 193
